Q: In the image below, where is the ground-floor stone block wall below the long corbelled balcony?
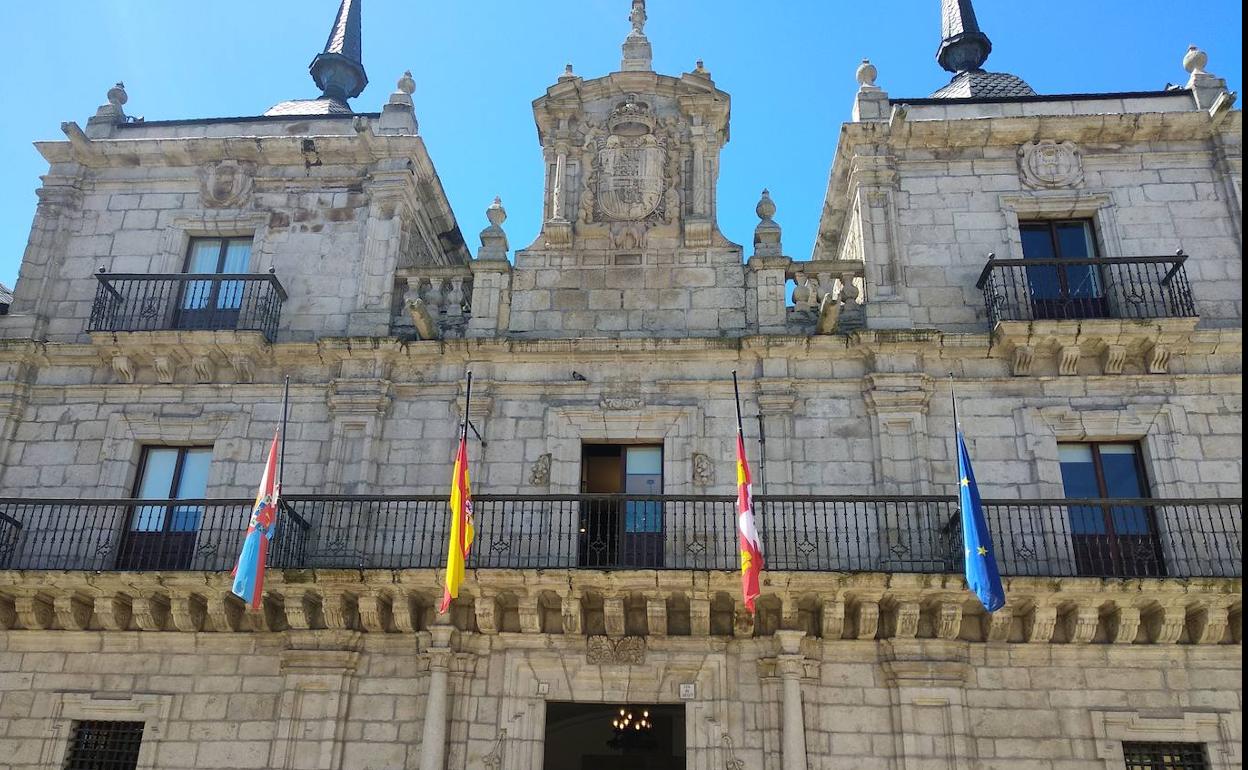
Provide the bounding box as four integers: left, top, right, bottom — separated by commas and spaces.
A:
0, 631, 1242, 770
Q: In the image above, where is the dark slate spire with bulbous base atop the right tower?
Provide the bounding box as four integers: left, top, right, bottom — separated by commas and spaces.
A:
932, 0, 1036, 99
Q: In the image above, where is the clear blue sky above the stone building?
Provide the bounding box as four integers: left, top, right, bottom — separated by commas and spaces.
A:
0, 0, 1243, 286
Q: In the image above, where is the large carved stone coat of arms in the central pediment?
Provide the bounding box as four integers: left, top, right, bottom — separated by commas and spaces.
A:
595, 134, 668, 221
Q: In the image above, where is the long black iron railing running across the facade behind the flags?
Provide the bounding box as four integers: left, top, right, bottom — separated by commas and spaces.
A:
0, 495, 1242, 578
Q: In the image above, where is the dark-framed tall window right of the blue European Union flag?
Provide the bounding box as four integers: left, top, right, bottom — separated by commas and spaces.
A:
1057, 443, 1164, 577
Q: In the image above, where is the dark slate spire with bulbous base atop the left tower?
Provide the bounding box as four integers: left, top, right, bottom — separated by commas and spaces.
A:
265, 0, 368, 117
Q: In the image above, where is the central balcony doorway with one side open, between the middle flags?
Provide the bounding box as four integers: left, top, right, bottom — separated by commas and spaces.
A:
577, 444, 663, 568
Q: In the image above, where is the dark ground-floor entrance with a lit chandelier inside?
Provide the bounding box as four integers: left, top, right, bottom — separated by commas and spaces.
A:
542, 703, 685, 770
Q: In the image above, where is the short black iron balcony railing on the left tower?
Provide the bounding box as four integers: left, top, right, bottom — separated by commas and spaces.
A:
87, 271, 286, 341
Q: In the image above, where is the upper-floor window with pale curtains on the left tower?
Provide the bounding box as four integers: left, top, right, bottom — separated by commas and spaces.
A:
177, 238, 252, 329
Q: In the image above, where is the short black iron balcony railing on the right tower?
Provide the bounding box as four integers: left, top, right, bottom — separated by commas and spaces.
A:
975, 251, 1197, 324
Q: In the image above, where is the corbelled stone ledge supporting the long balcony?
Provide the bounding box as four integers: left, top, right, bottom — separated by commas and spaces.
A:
0, 569, 1243, 645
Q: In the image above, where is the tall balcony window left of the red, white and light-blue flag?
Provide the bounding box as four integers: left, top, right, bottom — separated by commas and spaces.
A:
117, 447, 212, 569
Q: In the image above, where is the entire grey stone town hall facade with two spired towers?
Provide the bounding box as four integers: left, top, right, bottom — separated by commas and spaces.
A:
0, 0, 1243, 770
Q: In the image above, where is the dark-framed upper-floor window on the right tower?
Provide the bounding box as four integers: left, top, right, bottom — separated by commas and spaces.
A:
1018, 220, 1109, 318
